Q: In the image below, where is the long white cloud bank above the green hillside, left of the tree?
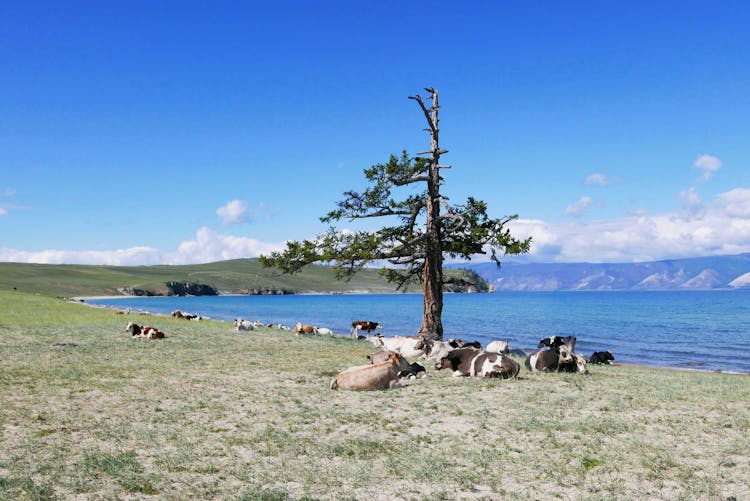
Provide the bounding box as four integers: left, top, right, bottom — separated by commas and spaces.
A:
0, 227, 284, 266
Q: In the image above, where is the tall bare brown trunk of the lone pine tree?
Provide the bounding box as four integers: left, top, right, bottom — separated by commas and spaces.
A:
417, 89, 443, 341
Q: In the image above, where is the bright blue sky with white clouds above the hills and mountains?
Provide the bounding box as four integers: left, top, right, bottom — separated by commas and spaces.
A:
0, 1, 750, 265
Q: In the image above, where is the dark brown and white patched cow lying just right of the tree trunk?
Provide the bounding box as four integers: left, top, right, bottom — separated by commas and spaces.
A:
435, 347, 521, 379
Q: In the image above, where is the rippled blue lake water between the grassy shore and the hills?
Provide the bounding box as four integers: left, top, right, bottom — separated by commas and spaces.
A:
87, 291, 750, 373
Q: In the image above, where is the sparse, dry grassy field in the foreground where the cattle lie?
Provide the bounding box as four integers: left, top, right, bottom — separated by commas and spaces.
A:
0, 292, 750, 500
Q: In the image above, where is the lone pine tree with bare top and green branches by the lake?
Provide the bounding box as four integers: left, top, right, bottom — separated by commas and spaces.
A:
260, 88, 531, 341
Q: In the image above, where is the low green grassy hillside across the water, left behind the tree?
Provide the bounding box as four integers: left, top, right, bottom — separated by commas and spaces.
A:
0, 259, 488, 297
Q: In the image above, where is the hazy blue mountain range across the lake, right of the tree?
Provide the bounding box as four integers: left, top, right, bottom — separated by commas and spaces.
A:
451, 253, 750, 291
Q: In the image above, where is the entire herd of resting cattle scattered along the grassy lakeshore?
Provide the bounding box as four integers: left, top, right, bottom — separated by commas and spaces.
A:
125, 310, 614, 390
